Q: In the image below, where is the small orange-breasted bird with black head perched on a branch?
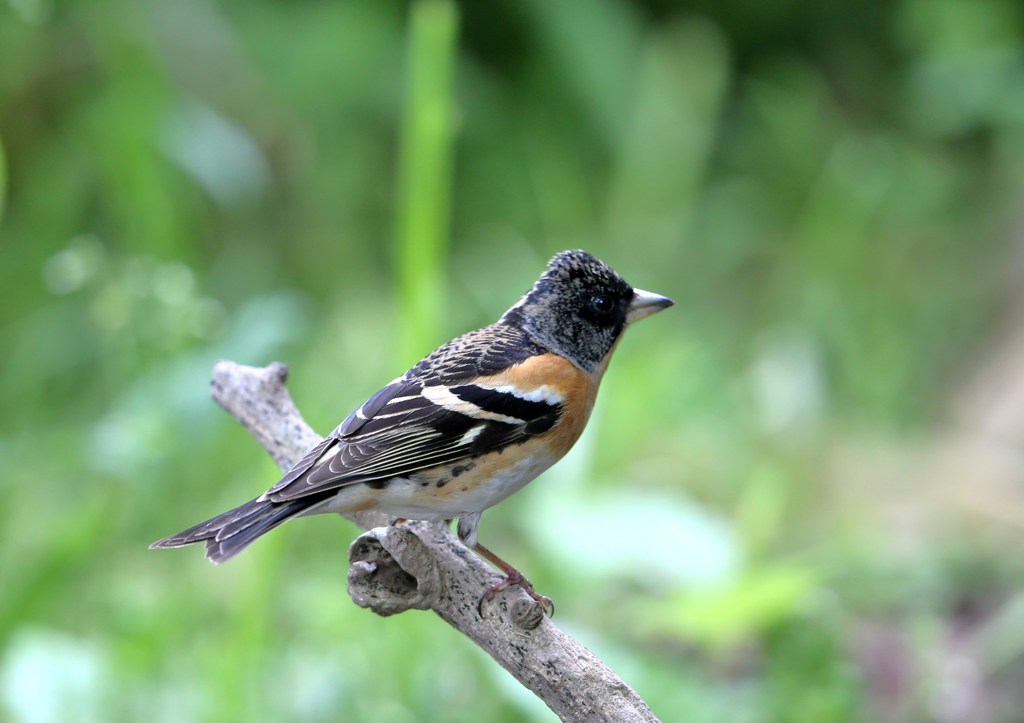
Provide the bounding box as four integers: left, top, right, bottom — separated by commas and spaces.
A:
151, 251, 674, 607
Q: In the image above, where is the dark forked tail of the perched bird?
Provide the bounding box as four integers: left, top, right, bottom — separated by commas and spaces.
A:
150, 497, 321, 564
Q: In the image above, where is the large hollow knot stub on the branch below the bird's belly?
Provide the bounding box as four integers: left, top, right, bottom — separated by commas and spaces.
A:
348, 525, 441, 618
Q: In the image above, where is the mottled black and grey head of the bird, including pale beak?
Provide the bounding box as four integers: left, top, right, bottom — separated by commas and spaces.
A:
502, 251, 673, 372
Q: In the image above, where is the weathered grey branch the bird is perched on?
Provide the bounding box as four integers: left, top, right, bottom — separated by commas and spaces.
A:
212, 362, 657, 723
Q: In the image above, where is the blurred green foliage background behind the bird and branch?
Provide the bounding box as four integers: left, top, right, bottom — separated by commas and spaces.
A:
0, 0, 1024, 722
